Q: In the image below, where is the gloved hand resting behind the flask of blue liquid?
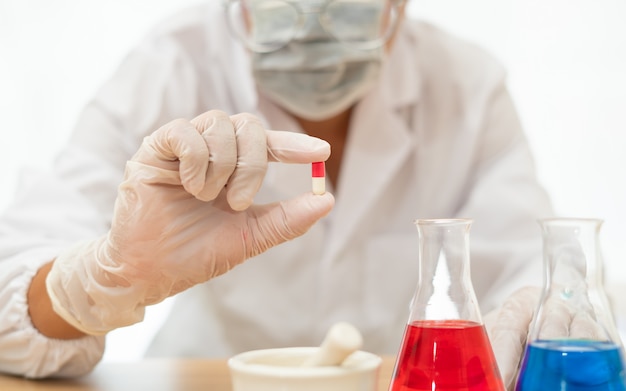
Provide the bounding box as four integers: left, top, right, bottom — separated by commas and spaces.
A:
484, 286, 606, 390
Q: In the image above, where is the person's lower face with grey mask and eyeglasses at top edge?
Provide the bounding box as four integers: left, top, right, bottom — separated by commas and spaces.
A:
224, 0, 397, 120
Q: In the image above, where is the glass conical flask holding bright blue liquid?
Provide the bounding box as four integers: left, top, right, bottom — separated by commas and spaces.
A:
515, 218, 626, 391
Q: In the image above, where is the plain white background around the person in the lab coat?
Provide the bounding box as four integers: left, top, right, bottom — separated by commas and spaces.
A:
0, 0, 626, 360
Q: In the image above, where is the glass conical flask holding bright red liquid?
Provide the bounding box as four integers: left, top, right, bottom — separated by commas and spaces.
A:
389, 219, 504, 391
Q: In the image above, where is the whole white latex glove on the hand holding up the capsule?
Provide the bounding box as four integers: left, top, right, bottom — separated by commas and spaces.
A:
46, 111, 334, 335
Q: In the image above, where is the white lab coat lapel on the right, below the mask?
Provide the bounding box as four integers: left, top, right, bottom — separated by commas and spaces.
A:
329, 52, 419, 259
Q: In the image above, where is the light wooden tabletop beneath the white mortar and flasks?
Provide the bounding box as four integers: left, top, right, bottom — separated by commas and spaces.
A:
0, 357, 394, 391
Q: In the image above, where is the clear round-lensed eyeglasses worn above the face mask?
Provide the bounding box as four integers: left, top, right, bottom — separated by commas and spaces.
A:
225, 0, 406, 53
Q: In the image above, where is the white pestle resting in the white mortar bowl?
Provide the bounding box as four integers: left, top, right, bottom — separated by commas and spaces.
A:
302, 322, 363, 367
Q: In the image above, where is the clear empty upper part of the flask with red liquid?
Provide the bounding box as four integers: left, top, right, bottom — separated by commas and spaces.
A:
410, 219, 482, 324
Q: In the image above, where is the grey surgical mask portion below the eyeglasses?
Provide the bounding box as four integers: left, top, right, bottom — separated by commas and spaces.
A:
245, 0, 383, 120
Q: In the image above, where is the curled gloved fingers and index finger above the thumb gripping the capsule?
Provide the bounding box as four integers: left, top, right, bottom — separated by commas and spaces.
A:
133, 110, 330, 210
